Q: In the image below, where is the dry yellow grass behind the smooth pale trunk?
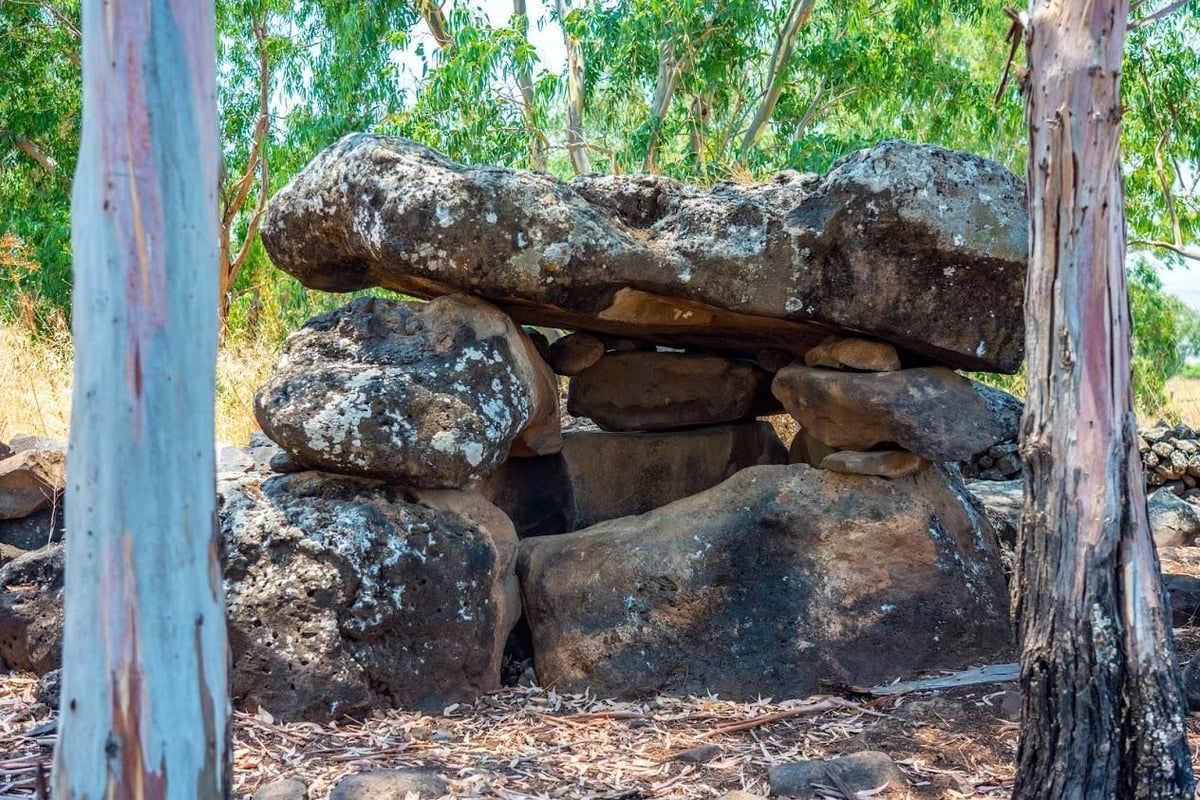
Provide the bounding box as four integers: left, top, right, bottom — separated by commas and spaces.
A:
0, 325, 278, 445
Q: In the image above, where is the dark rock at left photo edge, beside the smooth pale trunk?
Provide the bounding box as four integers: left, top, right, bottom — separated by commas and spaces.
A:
0, 545, 64, 675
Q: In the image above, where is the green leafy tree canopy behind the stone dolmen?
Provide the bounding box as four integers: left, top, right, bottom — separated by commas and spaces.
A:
0, 0, 1200, 393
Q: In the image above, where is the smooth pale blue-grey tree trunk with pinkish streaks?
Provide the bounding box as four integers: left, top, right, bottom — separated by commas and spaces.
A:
54, 0, 230, 800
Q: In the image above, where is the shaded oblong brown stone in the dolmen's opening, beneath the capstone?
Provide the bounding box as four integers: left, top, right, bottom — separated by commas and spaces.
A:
566, 353, 778, 431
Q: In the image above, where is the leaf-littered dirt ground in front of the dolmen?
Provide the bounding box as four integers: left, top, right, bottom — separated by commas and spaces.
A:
7, 628, 1200, 800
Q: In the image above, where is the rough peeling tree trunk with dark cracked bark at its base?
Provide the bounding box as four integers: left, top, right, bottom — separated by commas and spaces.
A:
1013, 0, 1193, 800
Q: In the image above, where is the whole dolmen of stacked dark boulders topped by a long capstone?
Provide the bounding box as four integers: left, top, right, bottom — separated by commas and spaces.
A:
0, 136, 1026, 718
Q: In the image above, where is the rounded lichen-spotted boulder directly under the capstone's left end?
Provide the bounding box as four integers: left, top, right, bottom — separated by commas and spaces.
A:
254, 296, 562, 488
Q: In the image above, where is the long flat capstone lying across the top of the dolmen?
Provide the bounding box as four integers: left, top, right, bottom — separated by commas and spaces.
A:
262, 134, 1027, 372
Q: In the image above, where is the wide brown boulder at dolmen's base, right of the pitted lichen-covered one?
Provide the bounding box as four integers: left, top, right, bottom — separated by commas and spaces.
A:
517, 464, 1012, 698
